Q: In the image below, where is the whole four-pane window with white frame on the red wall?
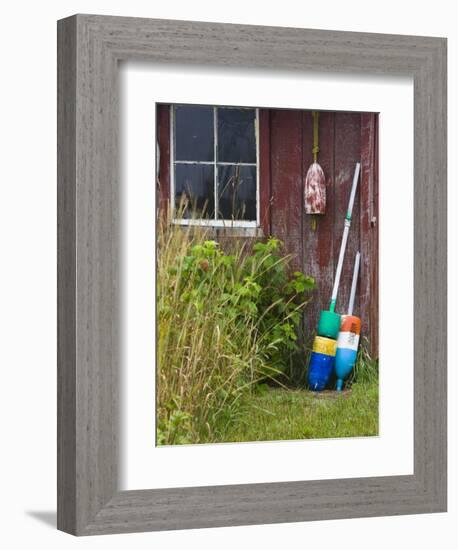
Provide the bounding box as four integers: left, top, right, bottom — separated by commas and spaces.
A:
171, 105, 259, 227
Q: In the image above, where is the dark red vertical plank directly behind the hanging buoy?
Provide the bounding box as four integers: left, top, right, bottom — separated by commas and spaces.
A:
302, 111, 335, 345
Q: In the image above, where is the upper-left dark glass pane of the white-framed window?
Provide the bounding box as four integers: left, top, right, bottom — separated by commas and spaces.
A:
175, 105, 214, 161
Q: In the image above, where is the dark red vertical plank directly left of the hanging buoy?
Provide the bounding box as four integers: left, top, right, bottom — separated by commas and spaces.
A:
271, 110, 303, 270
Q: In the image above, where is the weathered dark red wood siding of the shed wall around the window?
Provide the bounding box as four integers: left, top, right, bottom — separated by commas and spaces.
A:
157, 105, 378, 356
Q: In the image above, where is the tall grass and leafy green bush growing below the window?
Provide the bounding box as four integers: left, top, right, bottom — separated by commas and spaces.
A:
156, 220, 312, 445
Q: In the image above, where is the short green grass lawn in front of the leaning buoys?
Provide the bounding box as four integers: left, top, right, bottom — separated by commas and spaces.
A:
209, 380, 378, 443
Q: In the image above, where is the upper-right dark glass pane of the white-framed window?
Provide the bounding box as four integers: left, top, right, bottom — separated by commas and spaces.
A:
217, 108, 256, 163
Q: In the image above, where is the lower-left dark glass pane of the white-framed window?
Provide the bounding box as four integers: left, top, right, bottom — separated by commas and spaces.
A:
175, 164, 215, 219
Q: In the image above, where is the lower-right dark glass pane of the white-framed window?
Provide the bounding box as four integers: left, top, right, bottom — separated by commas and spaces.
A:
218, 165, 256, 221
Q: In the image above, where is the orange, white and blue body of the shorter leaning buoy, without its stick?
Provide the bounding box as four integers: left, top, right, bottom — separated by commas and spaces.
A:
335, 315, 361, 391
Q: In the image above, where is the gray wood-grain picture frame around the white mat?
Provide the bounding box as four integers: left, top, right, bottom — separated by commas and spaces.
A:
58, 15, 447, 535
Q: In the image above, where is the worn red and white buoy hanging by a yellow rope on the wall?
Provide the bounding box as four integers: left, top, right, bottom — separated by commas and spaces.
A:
304, 111, 326, 230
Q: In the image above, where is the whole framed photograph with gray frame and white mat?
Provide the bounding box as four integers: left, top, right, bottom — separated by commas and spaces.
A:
58, 15, 447, 535
